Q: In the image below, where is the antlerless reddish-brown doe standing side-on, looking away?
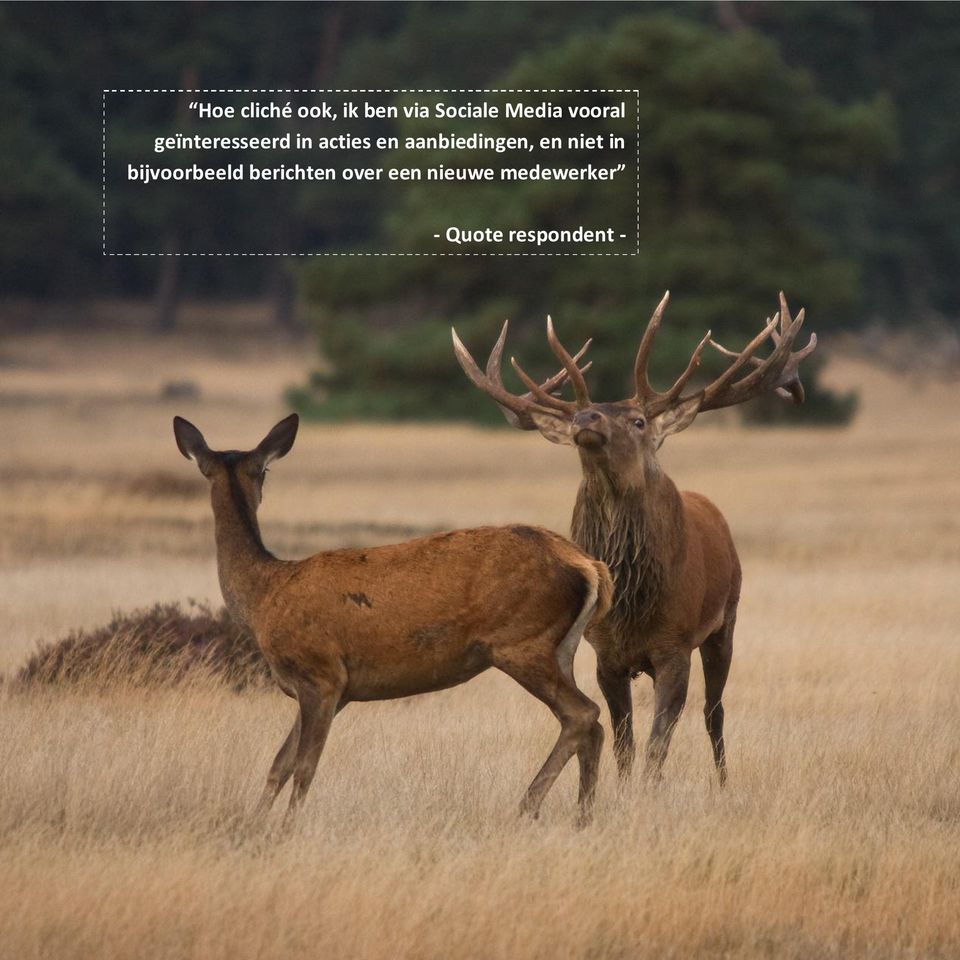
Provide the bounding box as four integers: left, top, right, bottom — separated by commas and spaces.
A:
173, 414, 612, 821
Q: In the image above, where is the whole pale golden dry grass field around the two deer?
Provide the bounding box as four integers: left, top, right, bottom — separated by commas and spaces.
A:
0, 320, 960, 960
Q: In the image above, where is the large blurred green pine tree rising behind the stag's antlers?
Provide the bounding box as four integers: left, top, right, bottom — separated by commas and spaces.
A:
297, 16, 892, 418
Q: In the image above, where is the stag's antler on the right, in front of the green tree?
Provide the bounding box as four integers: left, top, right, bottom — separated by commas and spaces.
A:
634, 291, 817, 417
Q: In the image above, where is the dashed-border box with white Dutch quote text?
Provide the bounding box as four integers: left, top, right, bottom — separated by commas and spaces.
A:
103, 90, 639, 256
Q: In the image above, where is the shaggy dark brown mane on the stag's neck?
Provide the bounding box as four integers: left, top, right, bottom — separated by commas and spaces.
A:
571, 472, 686, 640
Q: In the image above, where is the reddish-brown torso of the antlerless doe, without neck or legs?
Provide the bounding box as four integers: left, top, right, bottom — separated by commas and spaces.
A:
255, 526, 596, 700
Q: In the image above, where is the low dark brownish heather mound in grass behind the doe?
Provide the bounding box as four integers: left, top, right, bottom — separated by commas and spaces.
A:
16, 603, 273, 690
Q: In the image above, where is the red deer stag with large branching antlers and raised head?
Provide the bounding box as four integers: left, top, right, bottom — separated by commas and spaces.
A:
453, 293, 817, 784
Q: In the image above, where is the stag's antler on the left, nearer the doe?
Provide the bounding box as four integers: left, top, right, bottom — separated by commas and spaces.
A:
450, 317, 592, 430
